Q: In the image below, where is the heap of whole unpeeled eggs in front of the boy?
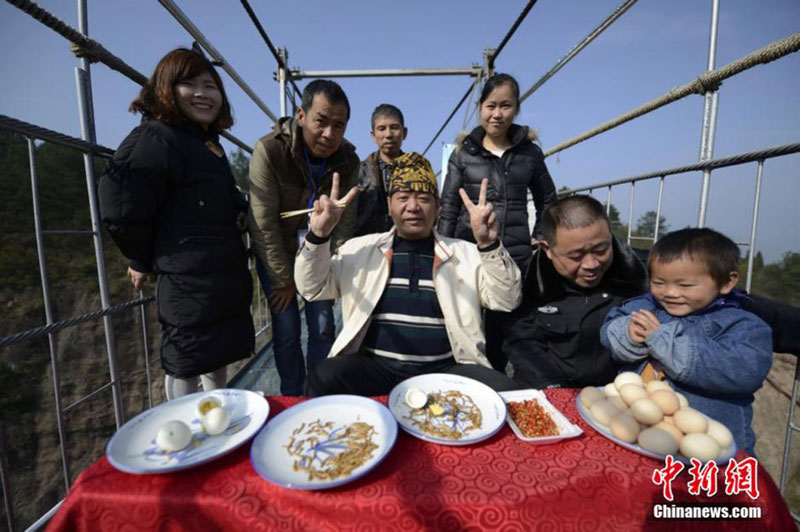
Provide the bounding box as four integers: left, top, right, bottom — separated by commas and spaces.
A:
579, 371, 733, 462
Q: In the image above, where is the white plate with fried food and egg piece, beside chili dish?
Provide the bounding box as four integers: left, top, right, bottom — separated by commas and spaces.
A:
389, 373, 506, 445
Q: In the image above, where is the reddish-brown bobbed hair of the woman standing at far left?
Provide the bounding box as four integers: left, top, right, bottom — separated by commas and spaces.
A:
129, 48, 233, 130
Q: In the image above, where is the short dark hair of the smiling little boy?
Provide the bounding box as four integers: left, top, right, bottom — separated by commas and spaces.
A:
648, 228, 739, 286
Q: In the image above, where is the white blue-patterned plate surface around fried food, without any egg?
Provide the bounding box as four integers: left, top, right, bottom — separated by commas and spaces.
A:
250, 395, 397, 490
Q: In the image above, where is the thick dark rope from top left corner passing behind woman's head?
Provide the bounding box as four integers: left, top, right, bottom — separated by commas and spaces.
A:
6, 0, 253, 153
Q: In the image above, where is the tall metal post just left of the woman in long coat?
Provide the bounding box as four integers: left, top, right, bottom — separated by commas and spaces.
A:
75, 0, 125, 428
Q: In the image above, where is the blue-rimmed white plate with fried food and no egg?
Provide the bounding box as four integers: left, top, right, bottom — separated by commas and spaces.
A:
250, 395, 397, 490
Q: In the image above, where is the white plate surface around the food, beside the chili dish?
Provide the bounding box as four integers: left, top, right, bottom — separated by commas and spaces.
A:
389, 373, 506, 445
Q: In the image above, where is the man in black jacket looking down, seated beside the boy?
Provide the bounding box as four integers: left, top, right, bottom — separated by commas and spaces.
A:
503, 196, 647, 388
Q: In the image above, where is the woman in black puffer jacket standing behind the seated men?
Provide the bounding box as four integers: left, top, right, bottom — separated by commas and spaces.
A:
438, 74, 556, 370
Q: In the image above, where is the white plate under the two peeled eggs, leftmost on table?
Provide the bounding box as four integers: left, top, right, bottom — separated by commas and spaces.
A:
106, 388, 269, 474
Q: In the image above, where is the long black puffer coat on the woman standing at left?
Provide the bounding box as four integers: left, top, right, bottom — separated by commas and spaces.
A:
98, 118, 254, 378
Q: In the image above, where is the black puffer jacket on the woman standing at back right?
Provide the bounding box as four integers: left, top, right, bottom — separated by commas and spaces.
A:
438, 124, 556, 272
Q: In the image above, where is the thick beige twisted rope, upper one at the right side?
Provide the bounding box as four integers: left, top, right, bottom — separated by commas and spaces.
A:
544, 31, 800, 157
